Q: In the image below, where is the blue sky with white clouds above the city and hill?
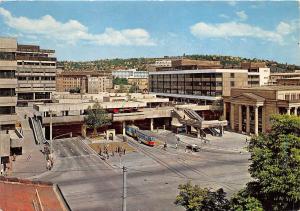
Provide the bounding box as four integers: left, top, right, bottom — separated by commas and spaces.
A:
0, 0, 300, 65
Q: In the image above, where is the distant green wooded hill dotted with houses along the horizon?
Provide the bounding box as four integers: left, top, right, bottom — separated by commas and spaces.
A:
58, 55, 300, 72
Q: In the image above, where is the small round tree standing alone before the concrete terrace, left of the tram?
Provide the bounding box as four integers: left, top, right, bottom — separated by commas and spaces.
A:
84, 103, 111, 135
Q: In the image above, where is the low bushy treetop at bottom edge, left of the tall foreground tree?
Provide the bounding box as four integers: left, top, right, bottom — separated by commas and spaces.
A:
174, 182, 229, 211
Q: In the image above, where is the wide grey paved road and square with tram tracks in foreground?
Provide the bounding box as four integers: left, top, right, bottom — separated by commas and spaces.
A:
38, 135, 249, 211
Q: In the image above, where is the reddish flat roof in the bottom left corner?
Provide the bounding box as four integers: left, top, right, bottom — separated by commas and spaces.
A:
0, 177, 69, 211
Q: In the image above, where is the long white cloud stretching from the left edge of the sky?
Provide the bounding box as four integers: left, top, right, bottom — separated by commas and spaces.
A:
0, 7, 155, 46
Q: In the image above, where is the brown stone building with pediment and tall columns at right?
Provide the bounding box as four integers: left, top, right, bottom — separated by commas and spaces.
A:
223, 86, 300, 134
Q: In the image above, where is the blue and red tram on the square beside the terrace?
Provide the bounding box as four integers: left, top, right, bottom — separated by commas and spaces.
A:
125, 125, 157, 146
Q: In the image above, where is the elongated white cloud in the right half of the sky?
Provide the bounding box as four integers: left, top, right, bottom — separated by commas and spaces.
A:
190, 22, 295, 44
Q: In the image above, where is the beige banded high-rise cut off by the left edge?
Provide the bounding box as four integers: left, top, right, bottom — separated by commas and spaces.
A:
0, 37, 23, 170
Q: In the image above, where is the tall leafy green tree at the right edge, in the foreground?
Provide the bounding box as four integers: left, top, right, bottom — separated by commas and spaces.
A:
247, 115, 300, 210
